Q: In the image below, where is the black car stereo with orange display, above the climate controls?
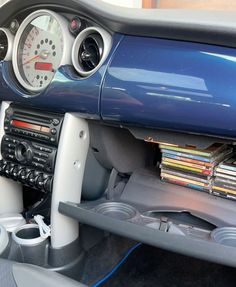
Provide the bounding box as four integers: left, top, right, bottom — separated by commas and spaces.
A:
4, 106, 63, 145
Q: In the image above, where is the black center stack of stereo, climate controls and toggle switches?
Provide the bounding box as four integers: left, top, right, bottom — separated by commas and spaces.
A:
0, 105, 63, 192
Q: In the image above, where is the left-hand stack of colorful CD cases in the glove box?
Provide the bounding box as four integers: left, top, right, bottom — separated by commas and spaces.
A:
159, 143, 231, 192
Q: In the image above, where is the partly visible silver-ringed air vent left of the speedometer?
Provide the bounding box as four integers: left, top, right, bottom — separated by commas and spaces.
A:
0, 28, 13, 61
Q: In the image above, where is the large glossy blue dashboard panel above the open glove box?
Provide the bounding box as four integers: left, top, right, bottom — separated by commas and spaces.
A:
101, 36, 236, 137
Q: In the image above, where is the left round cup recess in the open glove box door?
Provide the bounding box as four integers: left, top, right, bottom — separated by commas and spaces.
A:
95, 202, 137, 220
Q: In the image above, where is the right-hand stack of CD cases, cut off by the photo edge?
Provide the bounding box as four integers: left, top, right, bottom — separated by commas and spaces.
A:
212, 153, 236, 200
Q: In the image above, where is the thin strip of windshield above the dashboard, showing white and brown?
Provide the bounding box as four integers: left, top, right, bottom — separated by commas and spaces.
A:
102, 0, 236, 10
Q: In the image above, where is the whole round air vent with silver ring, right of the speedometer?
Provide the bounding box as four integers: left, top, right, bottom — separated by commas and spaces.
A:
72, 27, 112, 77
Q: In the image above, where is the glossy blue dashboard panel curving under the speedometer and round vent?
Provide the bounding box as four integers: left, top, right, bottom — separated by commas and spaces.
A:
0, 34, 122, 118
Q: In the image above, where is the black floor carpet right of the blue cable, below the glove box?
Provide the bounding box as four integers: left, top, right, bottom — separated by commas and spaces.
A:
99, 245, 236, 287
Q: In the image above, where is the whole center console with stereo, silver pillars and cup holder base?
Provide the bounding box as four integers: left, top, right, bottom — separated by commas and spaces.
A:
0, 102, 89, 272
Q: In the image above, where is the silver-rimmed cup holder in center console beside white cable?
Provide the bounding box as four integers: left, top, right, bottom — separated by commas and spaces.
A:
12, 224, 46, 245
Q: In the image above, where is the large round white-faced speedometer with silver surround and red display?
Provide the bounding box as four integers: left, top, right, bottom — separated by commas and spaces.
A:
13, 10, 72, 92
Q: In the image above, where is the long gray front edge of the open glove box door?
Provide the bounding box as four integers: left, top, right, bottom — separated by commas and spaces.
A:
59, 202, 236, 267
